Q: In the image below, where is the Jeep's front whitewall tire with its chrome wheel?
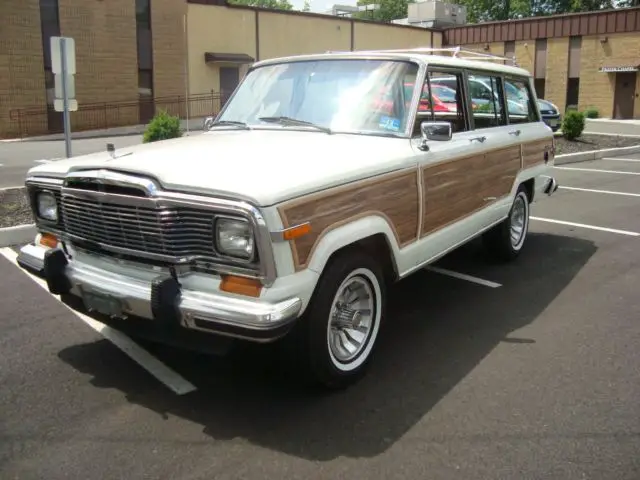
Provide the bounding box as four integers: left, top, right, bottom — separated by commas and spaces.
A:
291, 249, 386, 389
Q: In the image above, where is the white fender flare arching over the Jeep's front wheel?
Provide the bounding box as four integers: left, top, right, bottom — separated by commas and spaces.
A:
307, 214, 400, 274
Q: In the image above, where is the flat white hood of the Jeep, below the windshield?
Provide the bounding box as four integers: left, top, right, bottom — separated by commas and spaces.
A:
28, 129, 415, 206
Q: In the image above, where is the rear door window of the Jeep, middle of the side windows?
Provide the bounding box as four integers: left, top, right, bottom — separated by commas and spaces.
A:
468, 74, 507, 130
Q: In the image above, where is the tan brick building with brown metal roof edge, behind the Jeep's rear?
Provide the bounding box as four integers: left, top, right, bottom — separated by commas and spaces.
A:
443, 7, 640, 119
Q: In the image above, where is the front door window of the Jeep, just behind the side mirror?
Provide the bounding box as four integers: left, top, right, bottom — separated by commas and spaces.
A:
413, 70, 468, 136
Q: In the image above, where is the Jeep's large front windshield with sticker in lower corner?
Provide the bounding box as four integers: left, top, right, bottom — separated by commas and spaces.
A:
218, 59, 418, 135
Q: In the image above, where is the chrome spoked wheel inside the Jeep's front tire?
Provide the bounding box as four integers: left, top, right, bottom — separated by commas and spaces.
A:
327, 268, 381, 371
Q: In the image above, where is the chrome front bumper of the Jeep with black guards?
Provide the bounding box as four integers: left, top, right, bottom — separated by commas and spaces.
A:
31, 246, 302, 342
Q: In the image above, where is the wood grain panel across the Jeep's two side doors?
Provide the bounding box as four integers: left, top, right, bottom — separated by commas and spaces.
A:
421, 146, 521, 236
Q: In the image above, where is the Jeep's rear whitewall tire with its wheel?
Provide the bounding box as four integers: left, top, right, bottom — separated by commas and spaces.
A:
482, 185, 529, 262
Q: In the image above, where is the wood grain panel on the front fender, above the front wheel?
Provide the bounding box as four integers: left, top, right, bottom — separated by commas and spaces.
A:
279, 170, 418, 270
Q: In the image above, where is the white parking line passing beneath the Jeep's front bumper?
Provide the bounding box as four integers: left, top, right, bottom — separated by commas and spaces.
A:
0, 248, 196, 395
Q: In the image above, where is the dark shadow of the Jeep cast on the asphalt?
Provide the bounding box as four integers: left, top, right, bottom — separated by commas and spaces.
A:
59, 233, 596, 461
